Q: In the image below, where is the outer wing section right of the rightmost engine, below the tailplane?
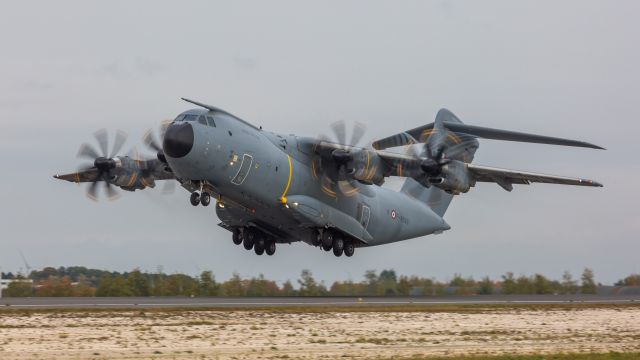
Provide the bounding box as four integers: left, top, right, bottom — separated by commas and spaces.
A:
467, 164, 603, 191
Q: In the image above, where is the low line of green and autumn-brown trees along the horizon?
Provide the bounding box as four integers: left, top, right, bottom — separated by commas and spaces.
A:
2, 267, 640, 297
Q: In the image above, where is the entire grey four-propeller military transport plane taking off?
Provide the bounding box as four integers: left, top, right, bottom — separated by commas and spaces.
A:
55, 98, 603, 256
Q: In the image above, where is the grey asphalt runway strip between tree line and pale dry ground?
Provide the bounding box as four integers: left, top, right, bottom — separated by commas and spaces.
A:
0, 295, 640, 310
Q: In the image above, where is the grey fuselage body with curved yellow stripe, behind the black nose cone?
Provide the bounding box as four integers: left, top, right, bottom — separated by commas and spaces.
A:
165, 109, 449, 246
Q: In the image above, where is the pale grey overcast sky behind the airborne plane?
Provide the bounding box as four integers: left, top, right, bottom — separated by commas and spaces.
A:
0, 1, 640, 283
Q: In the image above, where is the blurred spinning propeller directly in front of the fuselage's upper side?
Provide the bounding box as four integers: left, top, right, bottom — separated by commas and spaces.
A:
312, 120, 366, 197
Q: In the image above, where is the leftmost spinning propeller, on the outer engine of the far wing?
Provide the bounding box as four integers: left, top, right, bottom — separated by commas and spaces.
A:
77, 129, 128, 201
